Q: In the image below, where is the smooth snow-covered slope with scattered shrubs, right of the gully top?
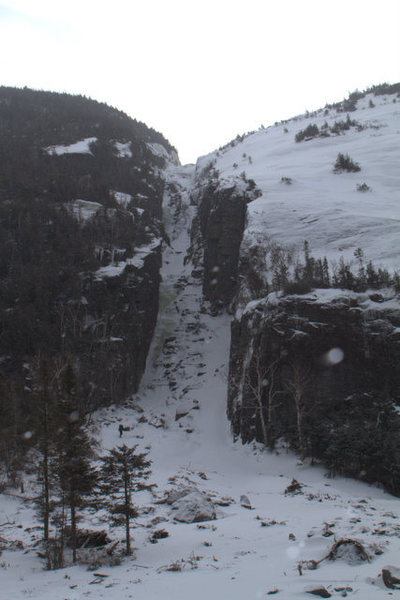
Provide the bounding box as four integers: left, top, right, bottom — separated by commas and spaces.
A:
197, 94, 400, 294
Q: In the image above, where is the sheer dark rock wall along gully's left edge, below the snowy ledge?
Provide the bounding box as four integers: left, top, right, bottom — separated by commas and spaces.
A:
78, 245, 161, 408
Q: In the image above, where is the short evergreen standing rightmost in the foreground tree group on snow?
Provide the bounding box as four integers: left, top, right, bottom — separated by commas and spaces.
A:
100, 444, 151, 556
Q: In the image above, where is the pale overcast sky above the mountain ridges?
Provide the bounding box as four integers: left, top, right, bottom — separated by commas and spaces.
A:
0, 0, 400, 164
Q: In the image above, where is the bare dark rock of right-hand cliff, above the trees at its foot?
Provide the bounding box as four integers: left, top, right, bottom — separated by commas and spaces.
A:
228, 294, 400, 441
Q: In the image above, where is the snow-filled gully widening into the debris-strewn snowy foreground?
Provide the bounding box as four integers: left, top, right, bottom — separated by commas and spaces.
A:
0, 159, 400, 600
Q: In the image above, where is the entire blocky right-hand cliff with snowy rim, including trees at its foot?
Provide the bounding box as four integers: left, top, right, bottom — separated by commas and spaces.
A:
228, 290, 400, 492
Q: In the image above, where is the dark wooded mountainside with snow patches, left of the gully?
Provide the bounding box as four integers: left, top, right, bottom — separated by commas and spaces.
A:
0, 88, 177, 408
